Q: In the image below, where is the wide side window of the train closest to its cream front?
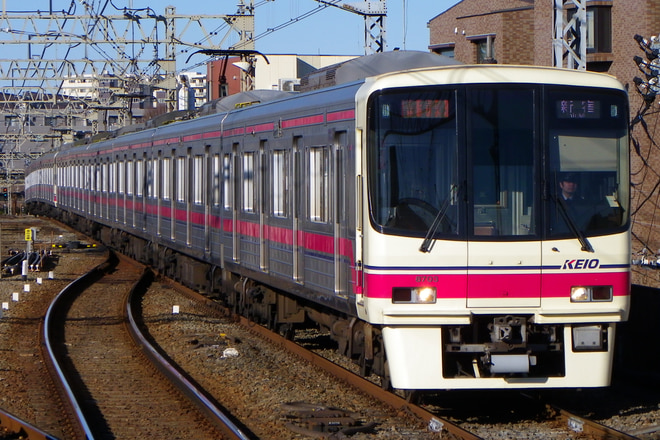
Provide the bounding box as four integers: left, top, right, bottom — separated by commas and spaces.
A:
308, 147, 330, 223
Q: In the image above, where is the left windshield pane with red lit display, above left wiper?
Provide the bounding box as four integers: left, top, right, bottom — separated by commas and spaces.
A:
369, 90, 460, 236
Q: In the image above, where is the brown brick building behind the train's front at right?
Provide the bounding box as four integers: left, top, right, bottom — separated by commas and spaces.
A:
429, 0, 660, 287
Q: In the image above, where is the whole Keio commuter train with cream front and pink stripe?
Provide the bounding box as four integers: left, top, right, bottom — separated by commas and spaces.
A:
25, 51, 631, 392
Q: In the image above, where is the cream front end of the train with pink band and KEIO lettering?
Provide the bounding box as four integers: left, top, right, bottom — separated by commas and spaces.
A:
355, 66, 630, 390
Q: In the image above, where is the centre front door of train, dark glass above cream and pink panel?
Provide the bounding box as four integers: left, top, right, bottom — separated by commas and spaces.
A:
466, 87, 541, 307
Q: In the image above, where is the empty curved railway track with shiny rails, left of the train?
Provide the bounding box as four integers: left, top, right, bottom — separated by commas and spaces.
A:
45, 251, 248, 439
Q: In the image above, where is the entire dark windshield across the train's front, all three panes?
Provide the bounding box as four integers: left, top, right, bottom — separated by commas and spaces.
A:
368, 85, 629, 241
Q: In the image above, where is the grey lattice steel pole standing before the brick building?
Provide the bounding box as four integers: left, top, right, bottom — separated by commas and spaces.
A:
552, 0, 587, 70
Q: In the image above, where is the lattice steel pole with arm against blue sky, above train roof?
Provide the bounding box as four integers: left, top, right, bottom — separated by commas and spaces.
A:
315, 0, 387, 55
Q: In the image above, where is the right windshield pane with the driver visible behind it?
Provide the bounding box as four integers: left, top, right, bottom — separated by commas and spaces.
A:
545, 89, 630, 239
